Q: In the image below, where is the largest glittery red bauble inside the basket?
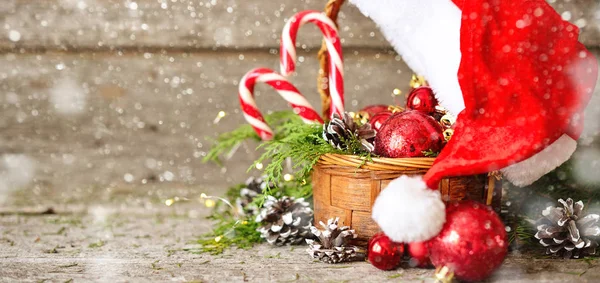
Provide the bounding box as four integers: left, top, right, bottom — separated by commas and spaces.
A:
375, 110, 444, 158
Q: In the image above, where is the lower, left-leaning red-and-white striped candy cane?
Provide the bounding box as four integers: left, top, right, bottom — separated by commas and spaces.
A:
239, 68, 323, 140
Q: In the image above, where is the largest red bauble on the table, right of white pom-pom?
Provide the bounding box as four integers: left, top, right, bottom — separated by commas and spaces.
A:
427, 201, 508, 281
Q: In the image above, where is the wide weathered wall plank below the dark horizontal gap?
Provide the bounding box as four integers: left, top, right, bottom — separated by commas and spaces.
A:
0, 49, 411, 193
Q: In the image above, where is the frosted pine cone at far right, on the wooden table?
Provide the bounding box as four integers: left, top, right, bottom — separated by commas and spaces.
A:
535, 198, 600, 258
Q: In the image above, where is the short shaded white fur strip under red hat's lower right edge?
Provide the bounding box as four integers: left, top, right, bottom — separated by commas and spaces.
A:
500, 134, 577, 187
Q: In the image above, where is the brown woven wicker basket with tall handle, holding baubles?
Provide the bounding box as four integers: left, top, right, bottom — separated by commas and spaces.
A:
312, 0, 502, 244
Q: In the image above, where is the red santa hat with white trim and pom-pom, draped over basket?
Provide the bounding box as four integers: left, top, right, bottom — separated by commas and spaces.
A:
351, 0, 598, 242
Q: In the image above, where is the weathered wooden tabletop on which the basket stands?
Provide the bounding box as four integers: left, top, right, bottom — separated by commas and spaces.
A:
0, 184, 600, 283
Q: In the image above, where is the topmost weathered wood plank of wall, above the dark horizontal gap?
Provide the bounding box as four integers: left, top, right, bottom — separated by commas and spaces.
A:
0, 0, 600, 50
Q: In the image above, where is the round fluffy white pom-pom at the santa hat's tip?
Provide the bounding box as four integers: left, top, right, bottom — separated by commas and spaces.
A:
372, 175, 446, 243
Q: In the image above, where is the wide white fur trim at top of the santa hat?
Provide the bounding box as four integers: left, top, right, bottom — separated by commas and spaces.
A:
350, 0, 465, 116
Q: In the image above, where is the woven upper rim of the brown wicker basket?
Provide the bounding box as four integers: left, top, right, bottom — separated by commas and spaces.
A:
317, 153, 435, 171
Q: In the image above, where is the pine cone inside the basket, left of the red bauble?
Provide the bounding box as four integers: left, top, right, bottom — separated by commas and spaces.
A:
323, 112, 376, 152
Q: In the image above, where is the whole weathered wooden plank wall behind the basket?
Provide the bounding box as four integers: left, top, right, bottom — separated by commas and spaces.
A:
0, 0, 600, 193
